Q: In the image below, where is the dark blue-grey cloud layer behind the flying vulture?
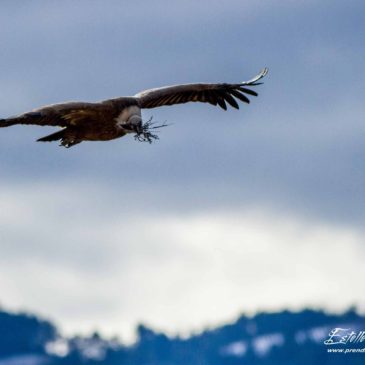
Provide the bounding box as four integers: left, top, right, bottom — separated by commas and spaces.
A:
0, 1, 365, 222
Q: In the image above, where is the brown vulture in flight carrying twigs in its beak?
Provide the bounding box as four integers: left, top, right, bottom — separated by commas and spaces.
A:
0, 68, 268, 148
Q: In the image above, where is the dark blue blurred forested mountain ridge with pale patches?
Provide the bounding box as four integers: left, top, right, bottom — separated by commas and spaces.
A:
0, 309, 365, 365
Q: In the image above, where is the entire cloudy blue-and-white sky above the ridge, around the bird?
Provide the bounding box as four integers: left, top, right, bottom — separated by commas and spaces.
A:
0, 0, 365, 338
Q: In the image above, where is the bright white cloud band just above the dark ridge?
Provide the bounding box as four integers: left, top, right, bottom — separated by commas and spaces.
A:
0, 183, 365, 339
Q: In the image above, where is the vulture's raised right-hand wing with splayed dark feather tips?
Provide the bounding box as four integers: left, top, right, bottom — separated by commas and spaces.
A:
135, 68, 268, 110
